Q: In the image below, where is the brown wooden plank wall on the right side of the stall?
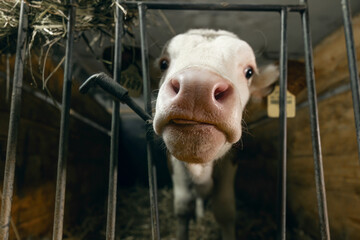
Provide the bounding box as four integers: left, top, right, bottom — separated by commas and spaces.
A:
237, 16, 360, 240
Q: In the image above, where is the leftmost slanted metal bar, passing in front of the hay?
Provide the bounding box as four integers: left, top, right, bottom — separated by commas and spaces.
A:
0, 0, 28, 240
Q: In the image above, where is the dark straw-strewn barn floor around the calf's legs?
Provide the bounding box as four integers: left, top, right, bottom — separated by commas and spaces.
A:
64, 186, 312, 240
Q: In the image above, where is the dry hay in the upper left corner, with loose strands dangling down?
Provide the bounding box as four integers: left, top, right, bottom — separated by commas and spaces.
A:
0, 0, 138, 94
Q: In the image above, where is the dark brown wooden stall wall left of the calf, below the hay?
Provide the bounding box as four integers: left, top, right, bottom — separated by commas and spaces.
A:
0, 53, 110, 239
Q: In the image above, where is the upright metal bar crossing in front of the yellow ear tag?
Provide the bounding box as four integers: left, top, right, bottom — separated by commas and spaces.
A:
278, 8, 288, 240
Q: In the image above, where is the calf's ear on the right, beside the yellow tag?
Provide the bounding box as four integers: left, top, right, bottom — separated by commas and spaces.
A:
250, 64, 279, 101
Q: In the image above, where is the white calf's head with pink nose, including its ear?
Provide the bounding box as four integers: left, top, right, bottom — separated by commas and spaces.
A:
153, 29, 278, 163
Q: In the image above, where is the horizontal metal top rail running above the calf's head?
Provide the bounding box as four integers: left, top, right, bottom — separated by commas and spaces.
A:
125, 2, 306, 12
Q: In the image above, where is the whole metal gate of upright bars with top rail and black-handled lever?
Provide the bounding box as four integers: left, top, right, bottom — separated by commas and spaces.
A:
0, 0, 360, 240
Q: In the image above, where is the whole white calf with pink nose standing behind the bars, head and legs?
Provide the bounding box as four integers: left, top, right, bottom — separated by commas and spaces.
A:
153, 29, 279, 240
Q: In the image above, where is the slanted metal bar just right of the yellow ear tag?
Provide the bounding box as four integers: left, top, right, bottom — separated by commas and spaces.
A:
301, 0, 330, 240
